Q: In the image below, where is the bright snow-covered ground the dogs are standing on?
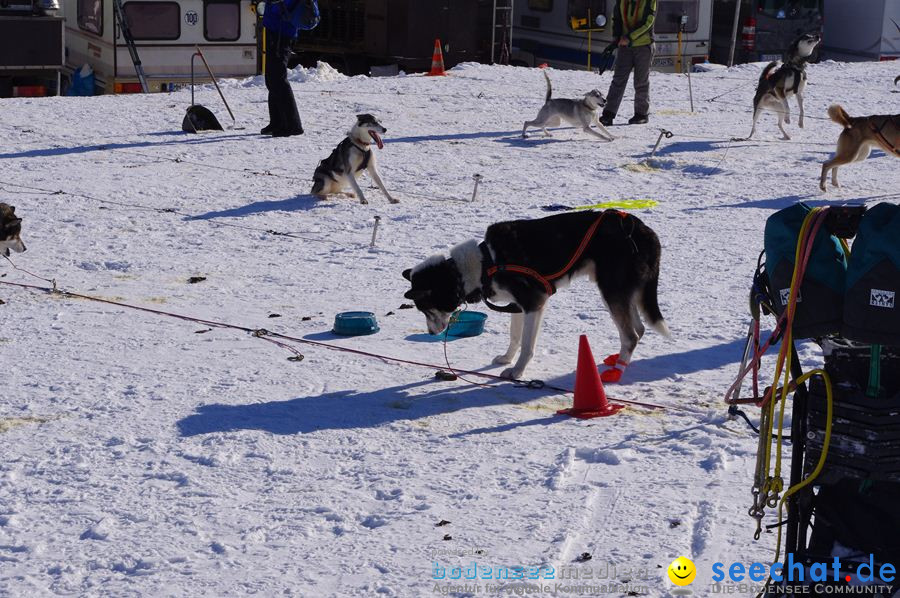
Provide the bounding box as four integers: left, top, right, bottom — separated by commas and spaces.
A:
0, 57, 900, 597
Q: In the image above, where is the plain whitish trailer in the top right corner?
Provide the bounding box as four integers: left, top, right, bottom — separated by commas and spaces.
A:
823, 0, 900, 61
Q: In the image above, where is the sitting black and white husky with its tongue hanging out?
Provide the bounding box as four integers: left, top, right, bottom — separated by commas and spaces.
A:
310, 114, 399, 203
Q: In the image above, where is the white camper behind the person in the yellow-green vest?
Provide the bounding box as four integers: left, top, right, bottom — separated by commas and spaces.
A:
512, 0, 713, 71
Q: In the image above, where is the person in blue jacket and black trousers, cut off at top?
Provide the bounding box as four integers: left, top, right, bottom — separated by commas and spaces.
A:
260, 0, 303, 137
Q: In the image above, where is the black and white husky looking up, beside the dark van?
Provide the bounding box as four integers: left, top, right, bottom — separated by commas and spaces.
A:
747, 33, 821, 139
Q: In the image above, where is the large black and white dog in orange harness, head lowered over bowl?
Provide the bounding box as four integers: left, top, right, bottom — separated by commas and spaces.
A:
403, 210, 669, 381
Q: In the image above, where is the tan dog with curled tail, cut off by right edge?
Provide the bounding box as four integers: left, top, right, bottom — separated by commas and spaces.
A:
819, 104, 900, 191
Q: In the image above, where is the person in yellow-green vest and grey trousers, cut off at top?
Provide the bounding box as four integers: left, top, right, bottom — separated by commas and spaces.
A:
600, 0, 656, 126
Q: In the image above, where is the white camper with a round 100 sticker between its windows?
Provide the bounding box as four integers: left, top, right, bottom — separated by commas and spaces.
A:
63, 0, 258, 93
